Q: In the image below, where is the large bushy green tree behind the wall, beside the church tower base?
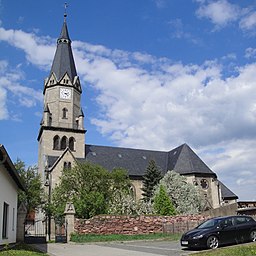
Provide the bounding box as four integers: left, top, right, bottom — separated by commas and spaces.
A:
49, 162, 130, 218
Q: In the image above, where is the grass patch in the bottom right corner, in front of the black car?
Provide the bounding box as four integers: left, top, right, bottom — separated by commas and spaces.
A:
193, 243, 256, 256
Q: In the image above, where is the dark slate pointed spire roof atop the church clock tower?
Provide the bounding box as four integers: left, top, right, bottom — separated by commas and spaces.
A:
50, 18, 77, 82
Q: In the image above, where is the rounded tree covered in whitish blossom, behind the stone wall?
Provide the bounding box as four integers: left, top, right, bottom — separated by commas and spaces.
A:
156, 171, 204, 214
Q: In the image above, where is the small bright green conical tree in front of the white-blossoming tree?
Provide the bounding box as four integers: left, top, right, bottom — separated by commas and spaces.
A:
153, 184, 176, 216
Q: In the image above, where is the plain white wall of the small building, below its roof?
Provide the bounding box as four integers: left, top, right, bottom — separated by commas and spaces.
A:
0, 165, 18, 245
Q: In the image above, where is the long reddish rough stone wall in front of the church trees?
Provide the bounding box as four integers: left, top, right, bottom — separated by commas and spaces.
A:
74, 215, 207, 235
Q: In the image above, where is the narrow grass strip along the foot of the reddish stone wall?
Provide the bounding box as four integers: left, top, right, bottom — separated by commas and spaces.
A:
71, 234, 180, 243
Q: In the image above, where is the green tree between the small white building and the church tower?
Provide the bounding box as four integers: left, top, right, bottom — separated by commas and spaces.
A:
14, 159, 45, 212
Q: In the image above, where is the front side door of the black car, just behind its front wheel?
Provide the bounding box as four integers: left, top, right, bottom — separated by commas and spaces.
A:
219, 217, 237, 244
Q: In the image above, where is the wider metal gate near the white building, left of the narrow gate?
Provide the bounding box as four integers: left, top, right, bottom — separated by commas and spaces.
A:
24, 219, 46, 244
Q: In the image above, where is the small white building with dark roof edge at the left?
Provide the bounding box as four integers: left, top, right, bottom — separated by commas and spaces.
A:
0, 144, 24, 245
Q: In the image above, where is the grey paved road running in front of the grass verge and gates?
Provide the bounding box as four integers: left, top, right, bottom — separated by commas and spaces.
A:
33, 241, 199, 256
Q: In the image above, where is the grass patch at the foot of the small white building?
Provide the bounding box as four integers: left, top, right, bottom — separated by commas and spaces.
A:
0, 244, 48, 256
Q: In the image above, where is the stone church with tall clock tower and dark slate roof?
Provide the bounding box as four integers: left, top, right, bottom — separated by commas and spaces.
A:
37, 15, 238, 212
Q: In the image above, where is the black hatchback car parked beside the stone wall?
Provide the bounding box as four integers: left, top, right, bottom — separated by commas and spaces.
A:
180, 215, 256, 249
